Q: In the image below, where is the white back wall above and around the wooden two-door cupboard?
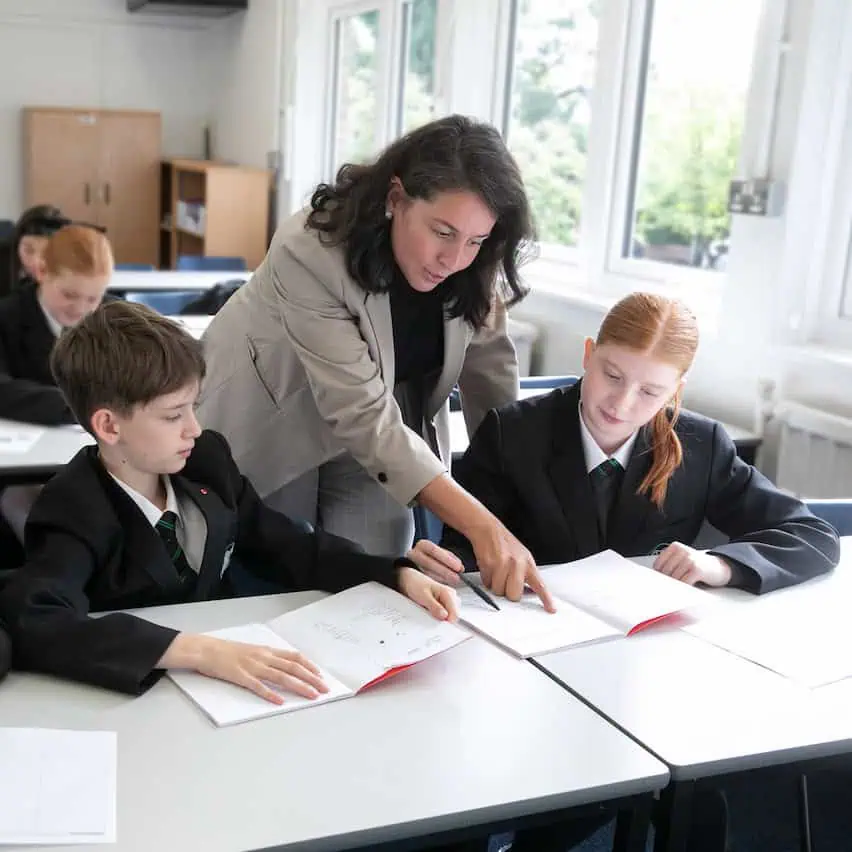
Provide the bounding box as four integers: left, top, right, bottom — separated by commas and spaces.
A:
0, 0, 216, 218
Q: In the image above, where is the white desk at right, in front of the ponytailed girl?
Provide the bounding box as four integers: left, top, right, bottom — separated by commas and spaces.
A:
534, 539, 852, 850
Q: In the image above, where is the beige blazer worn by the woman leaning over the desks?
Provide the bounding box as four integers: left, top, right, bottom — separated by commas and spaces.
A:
199, 212, 518, 505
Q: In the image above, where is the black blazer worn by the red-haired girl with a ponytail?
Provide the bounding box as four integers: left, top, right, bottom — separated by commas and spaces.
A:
442, 383, 840, 593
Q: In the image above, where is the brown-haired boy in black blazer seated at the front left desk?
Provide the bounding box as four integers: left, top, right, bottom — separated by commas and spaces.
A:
0, 301, 456, 703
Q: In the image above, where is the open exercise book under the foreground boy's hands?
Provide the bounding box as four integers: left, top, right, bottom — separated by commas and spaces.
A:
169, 583, 470, 726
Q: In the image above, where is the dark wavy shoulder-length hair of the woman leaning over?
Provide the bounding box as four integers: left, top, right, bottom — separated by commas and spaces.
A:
305, 115, 535, 328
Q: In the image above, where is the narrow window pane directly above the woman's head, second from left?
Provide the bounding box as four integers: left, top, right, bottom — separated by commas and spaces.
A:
398, 0, 438, 133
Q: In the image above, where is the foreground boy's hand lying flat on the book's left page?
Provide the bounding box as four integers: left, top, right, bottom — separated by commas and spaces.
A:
158, 633, 328, 704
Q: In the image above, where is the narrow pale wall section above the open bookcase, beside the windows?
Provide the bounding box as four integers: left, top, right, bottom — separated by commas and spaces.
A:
211, 0, 284, 168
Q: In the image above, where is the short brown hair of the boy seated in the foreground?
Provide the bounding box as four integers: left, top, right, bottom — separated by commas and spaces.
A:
50, 300, 205, 432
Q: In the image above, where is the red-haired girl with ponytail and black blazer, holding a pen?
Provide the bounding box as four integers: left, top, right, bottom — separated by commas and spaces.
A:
418, 293, 840, 852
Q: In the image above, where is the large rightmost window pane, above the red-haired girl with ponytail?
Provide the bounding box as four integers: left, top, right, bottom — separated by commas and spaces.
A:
624, 0, 762, 270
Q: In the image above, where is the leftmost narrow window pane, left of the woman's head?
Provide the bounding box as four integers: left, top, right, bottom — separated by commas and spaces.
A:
332, 9, 379, 168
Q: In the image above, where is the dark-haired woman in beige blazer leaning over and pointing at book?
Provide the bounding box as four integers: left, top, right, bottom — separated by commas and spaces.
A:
199, 116, 549, 603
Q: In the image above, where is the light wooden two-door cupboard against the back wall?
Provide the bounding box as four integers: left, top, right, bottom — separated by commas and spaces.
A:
23, 107, 161, 266
